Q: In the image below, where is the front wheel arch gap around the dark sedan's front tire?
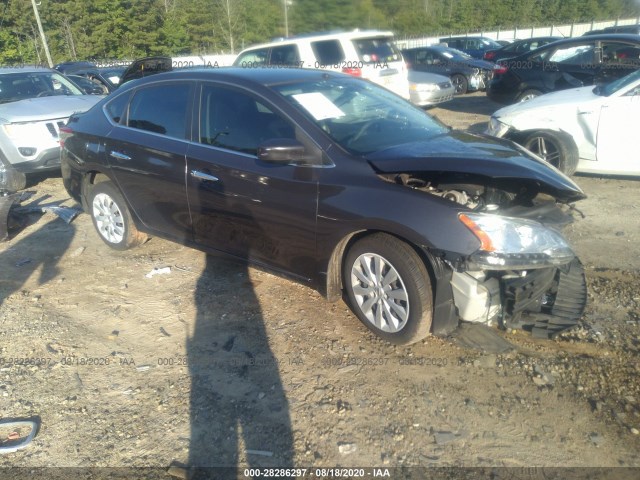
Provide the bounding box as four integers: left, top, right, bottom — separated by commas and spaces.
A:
325, 230, 436, 302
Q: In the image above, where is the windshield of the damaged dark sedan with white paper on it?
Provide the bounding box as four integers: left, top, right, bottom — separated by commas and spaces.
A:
274, 77, 448, 155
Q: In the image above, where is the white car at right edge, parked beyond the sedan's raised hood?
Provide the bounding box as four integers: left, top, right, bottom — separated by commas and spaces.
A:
486, 70, 640, 176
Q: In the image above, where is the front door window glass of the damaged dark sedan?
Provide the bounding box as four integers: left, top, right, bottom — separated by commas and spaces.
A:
199, 85, 296, 155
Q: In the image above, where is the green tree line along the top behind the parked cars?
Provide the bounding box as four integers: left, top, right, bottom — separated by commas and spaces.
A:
0, 0, 640, 65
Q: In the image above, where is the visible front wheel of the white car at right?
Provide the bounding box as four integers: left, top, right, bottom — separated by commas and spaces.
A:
523, 131, 578, 175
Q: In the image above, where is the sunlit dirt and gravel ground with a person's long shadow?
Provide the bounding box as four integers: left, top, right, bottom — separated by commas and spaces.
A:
0, 94, 640, 478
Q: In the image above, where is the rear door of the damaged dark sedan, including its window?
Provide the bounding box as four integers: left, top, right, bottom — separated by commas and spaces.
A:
105, 82, 192, 241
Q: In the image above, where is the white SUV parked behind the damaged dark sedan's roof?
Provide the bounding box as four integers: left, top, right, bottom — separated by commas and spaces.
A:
233, 30, 409, 99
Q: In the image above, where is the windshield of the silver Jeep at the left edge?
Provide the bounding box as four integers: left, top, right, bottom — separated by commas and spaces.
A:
0, 71, 83, 103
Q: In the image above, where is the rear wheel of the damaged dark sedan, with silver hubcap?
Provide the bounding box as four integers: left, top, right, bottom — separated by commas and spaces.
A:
87, 181, 147, 250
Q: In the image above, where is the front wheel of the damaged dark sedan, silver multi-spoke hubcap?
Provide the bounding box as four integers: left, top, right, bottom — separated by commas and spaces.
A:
343, 233, 433, 345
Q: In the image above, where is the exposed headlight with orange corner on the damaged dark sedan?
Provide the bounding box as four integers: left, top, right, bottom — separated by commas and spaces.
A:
459, 213, 575, 270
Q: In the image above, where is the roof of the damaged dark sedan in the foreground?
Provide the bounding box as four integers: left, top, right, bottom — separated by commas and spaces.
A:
112, 67, 353, 90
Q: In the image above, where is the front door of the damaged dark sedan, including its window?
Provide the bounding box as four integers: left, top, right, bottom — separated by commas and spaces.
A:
187, 85, 319, 278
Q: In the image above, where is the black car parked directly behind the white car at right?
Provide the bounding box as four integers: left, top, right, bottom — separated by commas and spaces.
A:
487, 34, 640, 104
